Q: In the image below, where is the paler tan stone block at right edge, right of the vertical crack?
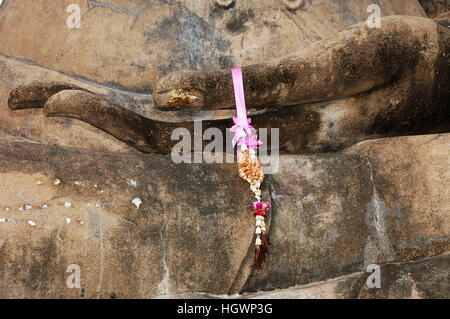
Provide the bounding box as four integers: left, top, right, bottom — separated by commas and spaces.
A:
346, 134, 450, 261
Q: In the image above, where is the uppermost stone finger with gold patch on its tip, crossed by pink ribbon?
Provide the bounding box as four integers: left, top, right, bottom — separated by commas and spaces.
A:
153, 17, 435, 113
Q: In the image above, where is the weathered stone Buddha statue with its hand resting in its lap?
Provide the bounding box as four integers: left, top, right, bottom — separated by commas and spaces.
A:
0, 0, 450, 297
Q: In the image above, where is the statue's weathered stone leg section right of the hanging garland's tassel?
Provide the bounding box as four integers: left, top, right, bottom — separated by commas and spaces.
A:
243, 134, 450, 291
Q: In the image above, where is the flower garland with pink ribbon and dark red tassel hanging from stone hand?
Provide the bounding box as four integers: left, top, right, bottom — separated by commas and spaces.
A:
230, 68, 270, 269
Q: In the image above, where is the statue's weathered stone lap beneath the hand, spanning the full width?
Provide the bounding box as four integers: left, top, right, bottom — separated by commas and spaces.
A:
0, 134, 450, 298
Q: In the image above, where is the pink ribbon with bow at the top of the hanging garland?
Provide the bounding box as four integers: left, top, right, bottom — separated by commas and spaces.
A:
230, 68, 262, 153
